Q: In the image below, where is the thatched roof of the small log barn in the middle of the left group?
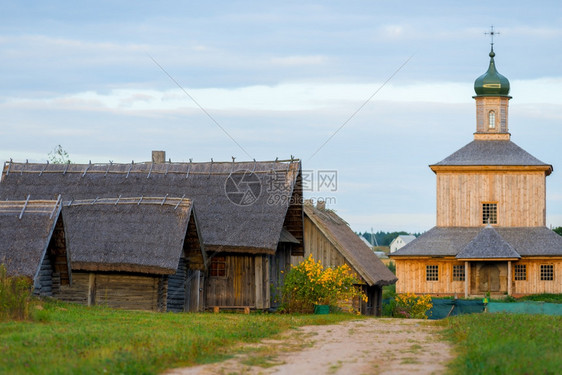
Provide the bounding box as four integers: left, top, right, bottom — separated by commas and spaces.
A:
63, 197, 203, 274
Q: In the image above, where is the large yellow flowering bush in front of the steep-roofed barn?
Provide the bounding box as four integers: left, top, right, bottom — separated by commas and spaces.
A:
281, 255, 367, 313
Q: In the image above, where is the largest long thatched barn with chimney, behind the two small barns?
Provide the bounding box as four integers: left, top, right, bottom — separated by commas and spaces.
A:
0, 155, 304, 309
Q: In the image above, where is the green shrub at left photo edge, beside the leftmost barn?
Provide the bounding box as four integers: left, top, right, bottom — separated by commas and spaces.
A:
0, 264, 31, 321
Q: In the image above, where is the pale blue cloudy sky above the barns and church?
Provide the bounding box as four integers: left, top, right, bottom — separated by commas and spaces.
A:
0, 0, 562, 232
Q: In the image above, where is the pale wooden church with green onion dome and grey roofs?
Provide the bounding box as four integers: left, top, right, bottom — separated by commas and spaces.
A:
391, 43, 562, 297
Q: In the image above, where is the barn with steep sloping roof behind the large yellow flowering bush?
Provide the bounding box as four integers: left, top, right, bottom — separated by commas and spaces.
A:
292, 201, 396, 316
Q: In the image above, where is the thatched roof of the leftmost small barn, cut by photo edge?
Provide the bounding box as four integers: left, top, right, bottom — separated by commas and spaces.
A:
0, 200, 68, 280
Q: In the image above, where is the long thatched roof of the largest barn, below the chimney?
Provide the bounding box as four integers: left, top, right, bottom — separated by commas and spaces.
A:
0, 160, 303, 254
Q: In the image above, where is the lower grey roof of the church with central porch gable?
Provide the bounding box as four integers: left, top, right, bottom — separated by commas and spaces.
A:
391, 227, 562, 258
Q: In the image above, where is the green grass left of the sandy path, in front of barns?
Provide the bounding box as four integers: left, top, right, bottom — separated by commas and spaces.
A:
0, 301, 357, 374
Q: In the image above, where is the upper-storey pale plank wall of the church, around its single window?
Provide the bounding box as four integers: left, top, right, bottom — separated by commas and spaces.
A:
437, 171, 546, 227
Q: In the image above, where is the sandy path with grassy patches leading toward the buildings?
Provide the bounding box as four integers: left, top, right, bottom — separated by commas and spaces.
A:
166, 319, 452, 375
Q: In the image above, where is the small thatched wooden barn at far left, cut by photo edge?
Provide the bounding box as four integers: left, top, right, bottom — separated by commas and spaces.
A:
0, 199, 72, 296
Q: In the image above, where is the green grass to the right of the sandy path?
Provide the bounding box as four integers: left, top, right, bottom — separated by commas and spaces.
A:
442, 314, 562, 375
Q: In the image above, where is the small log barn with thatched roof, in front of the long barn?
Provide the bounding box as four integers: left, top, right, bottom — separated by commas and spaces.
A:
55, 197, 206, 311
